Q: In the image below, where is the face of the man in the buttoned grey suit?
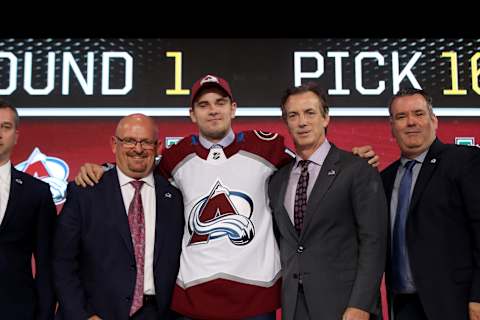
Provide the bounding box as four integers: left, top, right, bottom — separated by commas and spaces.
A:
284, 91, 330, 159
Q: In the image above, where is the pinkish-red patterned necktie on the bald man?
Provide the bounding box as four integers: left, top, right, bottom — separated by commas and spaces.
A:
128, 180, 145, 316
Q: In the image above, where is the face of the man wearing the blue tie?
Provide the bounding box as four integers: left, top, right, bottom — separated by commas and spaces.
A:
390, 94, 438, 158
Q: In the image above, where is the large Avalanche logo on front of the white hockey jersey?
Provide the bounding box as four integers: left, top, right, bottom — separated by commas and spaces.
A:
188, 181, 255, 246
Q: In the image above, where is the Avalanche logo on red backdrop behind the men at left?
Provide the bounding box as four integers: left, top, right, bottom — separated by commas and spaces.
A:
15, 148, 69, 205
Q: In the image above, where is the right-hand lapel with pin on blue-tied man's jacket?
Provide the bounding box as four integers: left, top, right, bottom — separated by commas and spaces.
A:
409, 139, 444, 210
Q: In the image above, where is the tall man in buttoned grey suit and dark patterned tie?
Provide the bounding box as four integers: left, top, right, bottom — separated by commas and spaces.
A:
269, 84, 387, 320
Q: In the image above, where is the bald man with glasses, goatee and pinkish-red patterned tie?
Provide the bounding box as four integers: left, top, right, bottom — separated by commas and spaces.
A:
54, 114, 184, 320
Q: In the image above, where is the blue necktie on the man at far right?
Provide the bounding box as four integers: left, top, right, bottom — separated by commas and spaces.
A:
392, 160, 416, 293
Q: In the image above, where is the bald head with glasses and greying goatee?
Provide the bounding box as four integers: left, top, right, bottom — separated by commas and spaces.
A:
111, 113, 159, 179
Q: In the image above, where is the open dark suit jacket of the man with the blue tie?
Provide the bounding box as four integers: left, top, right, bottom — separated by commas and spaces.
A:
382, 140, 480, 320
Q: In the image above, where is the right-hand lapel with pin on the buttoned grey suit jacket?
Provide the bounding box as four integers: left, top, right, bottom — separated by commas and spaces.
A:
300, 144, 340, 236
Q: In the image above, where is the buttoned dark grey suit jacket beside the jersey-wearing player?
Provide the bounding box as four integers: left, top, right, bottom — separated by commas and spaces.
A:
269, 145, 387, 320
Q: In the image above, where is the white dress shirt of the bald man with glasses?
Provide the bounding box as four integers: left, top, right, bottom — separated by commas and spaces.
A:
117, 167, 156, 295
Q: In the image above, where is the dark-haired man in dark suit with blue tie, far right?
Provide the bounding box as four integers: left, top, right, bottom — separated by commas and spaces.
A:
382, 88, 480, 320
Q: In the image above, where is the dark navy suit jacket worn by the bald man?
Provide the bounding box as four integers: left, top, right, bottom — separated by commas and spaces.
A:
54, 169, 184, 320
